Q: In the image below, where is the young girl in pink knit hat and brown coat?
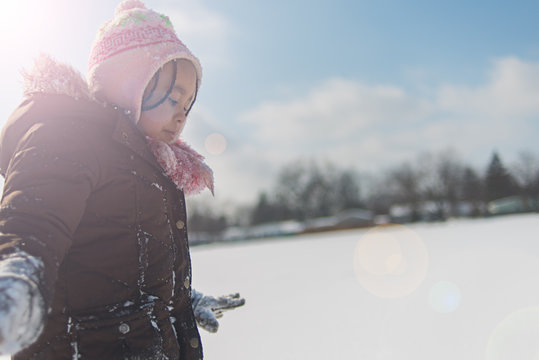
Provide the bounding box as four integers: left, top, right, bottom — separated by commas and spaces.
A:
0, 0, 244, 360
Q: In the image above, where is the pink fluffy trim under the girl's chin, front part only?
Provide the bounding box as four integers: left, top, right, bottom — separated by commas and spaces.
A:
146, 137, 213, 195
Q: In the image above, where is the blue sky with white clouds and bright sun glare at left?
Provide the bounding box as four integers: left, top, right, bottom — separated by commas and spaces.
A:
0, 0, 539, 202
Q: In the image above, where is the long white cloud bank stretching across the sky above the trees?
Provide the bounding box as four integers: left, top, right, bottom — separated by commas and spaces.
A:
204, 58, 539, 202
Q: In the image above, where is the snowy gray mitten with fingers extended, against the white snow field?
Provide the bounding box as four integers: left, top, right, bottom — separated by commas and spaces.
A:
191, 289, 245, 333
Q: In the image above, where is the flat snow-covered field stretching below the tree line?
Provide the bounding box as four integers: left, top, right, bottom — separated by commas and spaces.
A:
192, 214, 539, 360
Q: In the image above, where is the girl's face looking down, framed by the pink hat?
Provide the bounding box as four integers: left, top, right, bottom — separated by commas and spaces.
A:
137, 59, 197, 144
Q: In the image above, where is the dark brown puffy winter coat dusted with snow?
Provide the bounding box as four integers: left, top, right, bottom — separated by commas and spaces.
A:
0, 94, 202, 360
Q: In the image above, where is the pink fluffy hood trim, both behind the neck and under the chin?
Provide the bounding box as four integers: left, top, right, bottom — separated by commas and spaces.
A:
19, 54, 213, 195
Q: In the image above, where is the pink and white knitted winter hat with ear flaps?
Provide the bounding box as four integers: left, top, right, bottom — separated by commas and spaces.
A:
87, 0, 202, 122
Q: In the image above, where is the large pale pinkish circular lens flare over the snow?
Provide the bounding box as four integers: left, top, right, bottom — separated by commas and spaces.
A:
354, 225, 428, 298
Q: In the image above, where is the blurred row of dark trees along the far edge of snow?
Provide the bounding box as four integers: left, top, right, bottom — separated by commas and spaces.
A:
190, 150, 539, 232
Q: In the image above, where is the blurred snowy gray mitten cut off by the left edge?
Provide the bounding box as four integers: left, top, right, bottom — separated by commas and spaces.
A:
0, 254, 45, 355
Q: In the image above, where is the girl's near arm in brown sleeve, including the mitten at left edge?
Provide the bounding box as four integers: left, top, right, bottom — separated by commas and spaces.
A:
0, 100, 96, 353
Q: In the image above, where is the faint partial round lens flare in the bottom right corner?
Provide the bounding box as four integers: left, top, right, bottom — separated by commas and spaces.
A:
486, 306, 539, 360
